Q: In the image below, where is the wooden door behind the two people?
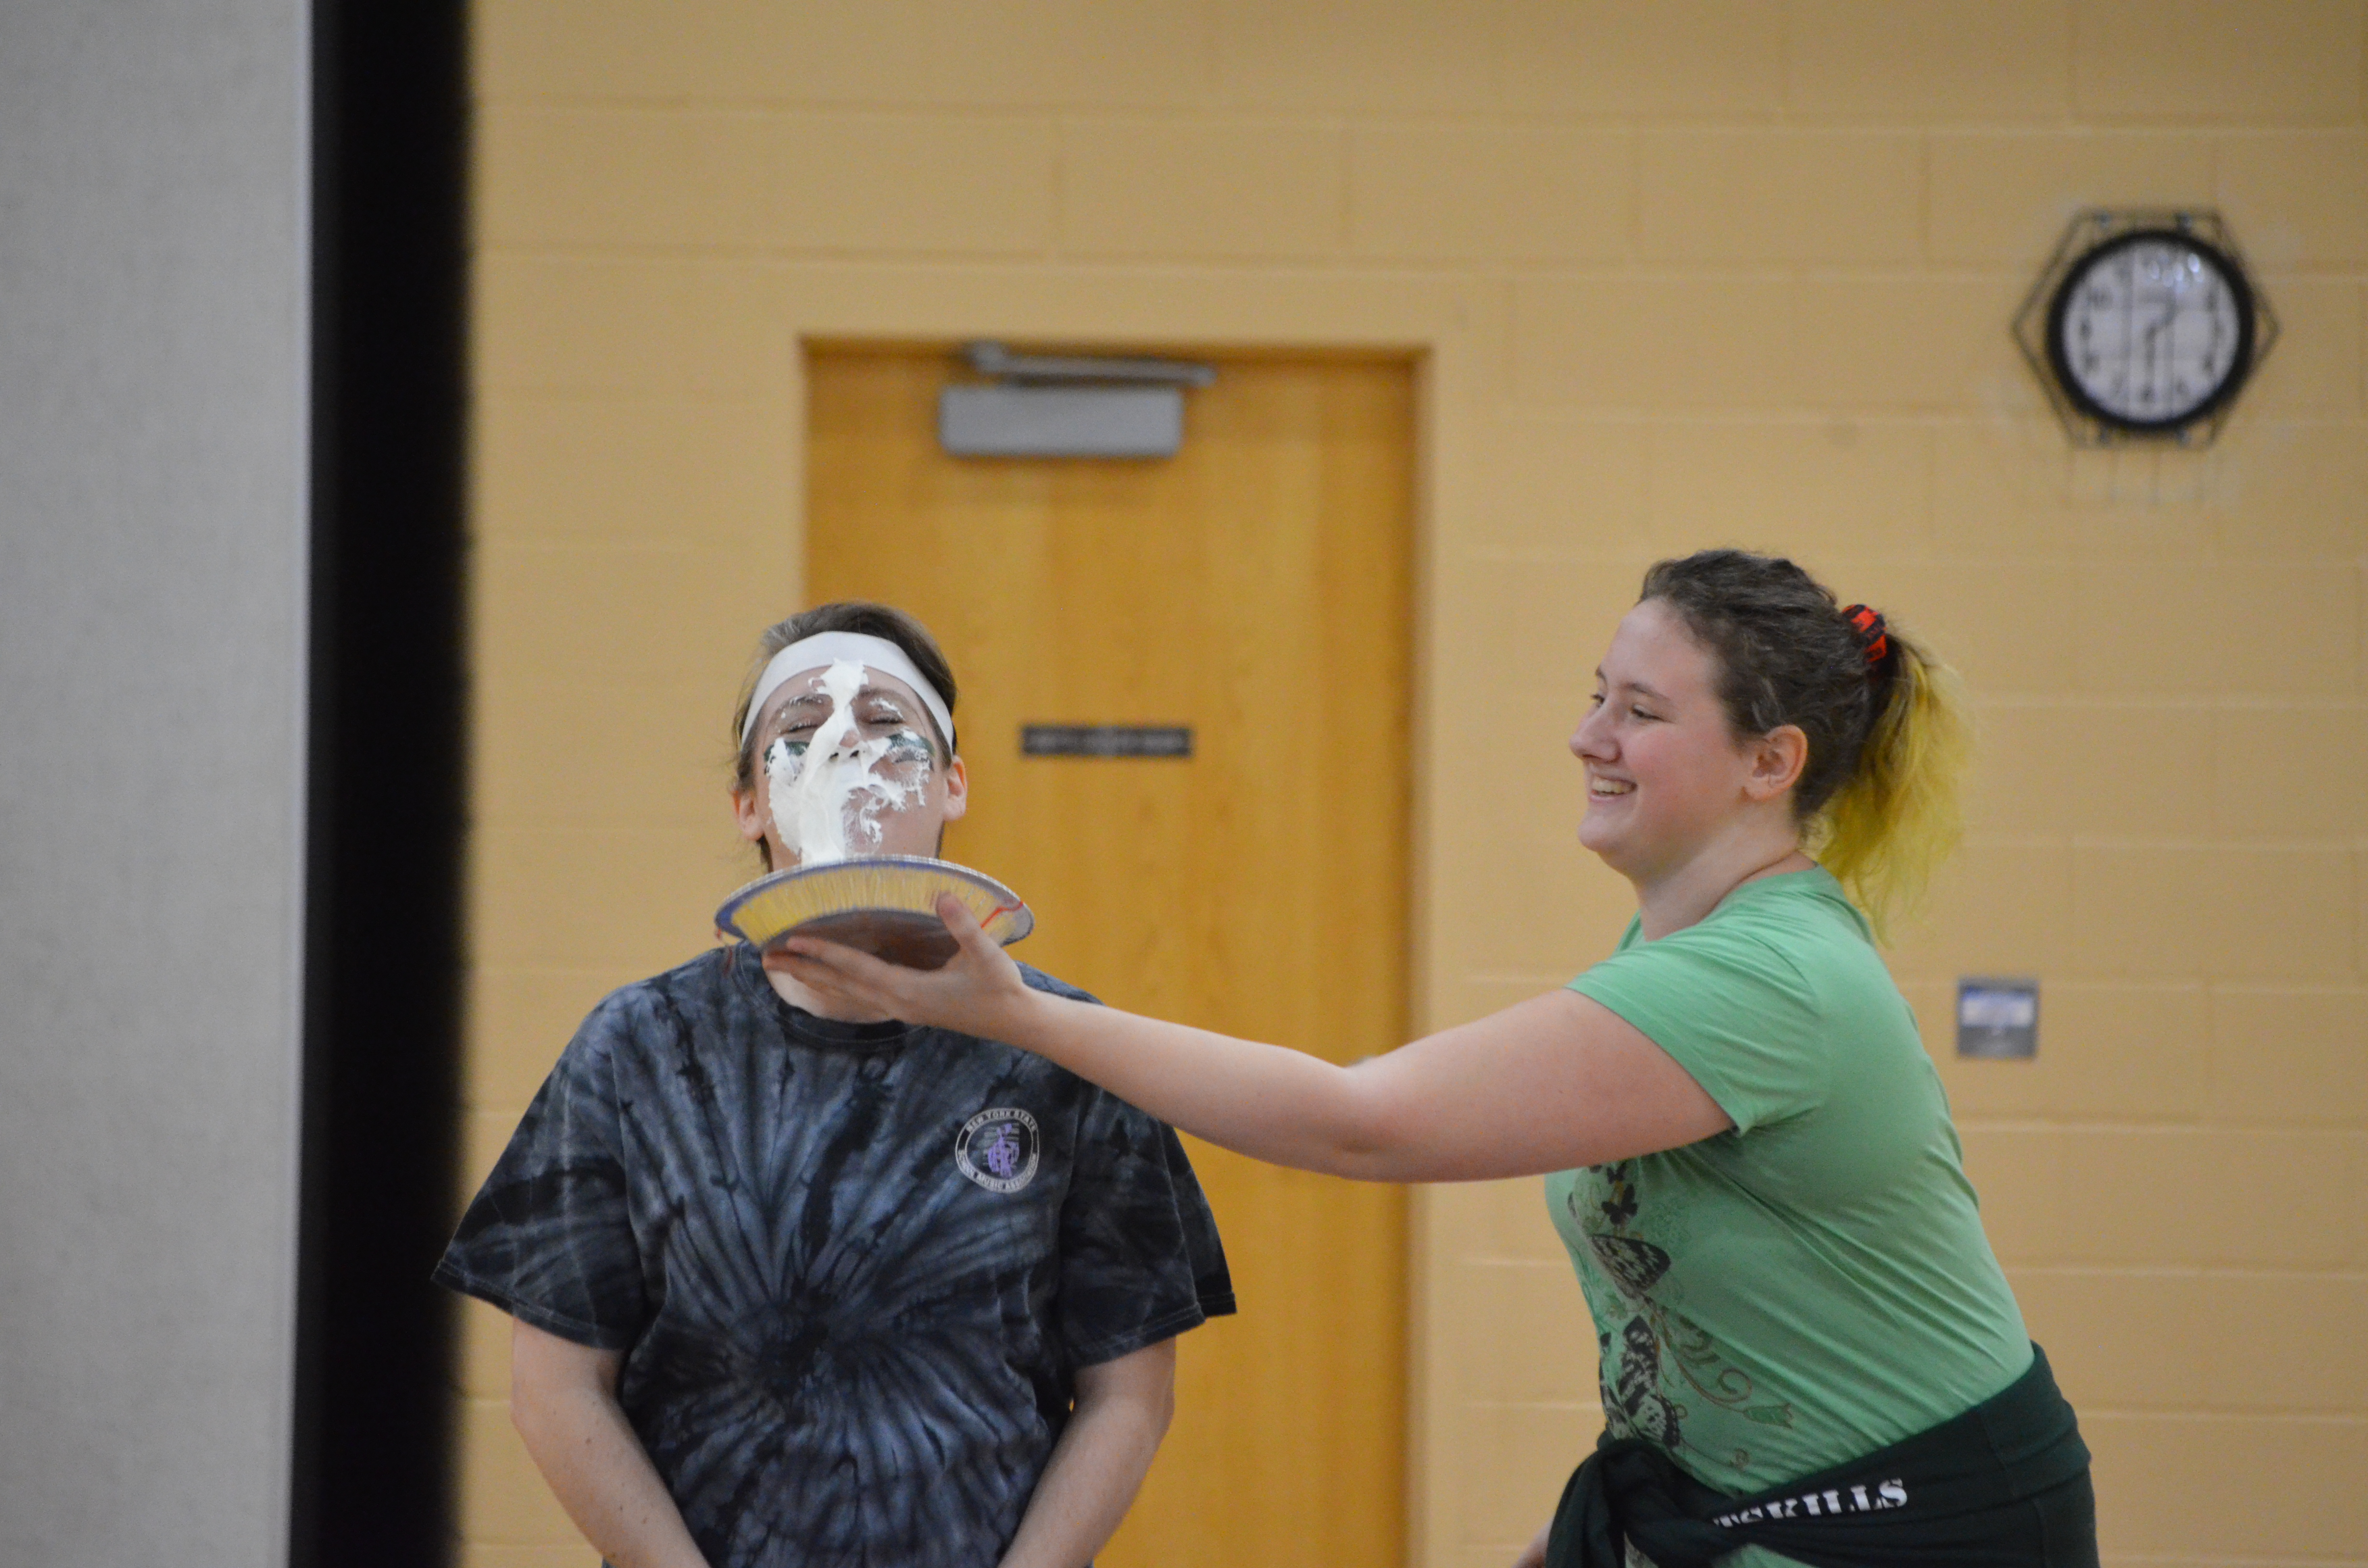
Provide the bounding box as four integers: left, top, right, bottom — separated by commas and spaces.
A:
807, 348, 1414, 1568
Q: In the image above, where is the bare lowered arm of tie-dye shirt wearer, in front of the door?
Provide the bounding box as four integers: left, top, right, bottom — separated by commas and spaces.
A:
1002, 1338, 1177, 1568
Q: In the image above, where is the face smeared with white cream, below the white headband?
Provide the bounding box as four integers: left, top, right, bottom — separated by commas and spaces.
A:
732, 663, 969, 869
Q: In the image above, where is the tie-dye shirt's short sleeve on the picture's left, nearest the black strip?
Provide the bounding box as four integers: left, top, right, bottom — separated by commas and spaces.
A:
436, 1000, 649, 1350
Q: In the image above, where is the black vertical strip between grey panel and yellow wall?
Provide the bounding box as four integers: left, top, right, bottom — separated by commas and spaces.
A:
289, 0, 469, 1568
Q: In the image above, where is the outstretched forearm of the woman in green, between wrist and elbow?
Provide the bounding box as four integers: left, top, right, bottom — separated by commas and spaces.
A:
999, 990, 1395, 1179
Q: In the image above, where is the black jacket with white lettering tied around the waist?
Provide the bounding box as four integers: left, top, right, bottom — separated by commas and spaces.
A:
1546, 1346, 2096, 1568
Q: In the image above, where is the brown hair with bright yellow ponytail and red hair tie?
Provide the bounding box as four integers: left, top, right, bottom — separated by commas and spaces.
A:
1639, 550, 1970, 931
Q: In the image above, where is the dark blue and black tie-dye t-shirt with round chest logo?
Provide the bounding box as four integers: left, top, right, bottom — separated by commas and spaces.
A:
436, 947, 1233, 1568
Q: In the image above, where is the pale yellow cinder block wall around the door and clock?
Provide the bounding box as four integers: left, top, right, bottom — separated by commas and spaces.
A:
457, 0, 2368, 1568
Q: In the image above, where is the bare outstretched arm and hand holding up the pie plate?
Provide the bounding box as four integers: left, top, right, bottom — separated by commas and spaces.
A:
786, 898, 1731, 1182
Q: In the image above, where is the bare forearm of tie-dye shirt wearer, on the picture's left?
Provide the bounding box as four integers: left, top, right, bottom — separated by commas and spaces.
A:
511, 1388, 708, 1568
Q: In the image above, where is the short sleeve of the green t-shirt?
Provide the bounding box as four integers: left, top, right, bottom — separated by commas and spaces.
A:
1570, 921, 1833, 1132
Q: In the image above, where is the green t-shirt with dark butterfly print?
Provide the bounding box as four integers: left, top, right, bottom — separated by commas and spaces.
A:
1546, 869, 2032, 1525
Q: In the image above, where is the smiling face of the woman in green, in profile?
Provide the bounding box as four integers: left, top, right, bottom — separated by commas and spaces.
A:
1570, 599, 1800, 883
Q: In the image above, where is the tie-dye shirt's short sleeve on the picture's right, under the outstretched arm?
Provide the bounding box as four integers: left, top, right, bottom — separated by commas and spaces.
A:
1059, 1087, 1233, 1367
